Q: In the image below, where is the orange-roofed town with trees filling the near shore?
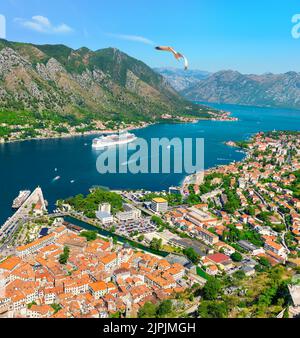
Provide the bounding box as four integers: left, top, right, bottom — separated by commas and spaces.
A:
0, 132, 300, 318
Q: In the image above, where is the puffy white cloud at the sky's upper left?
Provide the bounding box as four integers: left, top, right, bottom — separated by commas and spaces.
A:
15, 15, 73, 34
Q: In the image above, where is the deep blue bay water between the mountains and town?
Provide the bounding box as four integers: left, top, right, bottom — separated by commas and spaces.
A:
0, 104, 300, 224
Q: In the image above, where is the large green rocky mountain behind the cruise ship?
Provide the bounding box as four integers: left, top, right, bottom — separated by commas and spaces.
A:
0, 39, 206, 122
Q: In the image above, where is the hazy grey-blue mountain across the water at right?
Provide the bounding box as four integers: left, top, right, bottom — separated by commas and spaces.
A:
181, 70, 300, 109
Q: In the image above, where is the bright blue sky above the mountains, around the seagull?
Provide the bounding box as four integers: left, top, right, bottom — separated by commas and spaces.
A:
0, 0, 300, 73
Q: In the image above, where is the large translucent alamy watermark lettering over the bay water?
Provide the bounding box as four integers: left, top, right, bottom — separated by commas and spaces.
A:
96, 138, 204, 175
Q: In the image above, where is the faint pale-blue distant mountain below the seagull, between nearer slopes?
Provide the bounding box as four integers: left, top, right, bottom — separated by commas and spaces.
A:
154, 68, 210, 91
